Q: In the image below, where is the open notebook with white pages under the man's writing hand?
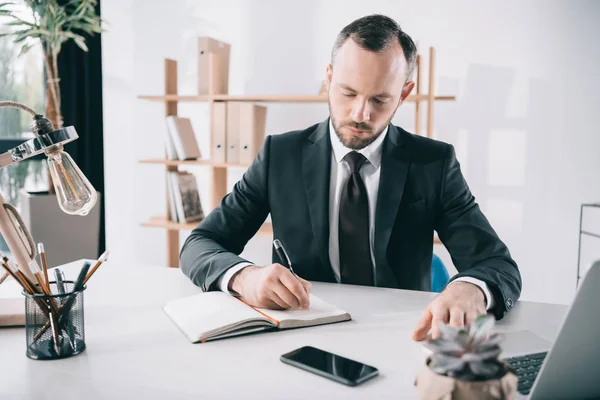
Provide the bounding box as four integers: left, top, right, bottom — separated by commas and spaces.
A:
163, 292, 351, 343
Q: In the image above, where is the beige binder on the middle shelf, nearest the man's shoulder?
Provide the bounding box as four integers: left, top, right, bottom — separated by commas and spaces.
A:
239, 103, 267, 164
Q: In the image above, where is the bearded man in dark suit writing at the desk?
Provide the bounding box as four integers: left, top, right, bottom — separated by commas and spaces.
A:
181, 15, 521, 340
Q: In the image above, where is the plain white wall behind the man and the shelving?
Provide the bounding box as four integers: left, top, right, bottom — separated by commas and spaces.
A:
102, 0, 600, 303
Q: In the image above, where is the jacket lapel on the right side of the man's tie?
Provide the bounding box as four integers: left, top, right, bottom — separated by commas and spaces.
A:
374, 124, 410, 288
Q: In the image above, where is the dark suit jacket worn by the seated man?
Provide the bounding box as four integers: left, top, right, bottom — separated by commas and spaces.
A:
180, 120, 521, 318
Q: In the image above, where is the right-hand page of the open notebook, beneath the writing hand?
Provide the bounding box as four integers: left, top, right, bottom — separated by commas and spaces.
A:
257, 294, 350, 328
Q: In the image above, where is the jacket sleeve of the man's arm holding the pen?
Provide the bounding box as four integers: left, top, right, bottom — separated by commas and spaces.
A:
180, 136, 271, 291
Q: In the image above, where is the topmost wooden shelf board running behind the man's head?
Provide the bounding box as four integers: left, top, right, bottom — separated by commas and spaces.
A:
138, 94, 456, 103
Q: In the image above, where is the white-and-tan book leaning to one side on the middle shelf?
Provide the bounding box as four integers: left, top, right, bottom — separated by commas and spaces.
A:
166, 115, 201, 160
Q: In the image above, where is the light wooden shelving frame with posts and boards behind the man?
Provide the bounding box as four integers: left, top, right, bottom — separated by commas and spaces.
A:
138, 48, 456, 267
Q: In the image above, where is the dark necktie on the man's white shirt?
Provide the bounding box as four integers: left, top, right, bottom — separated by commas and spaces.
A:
338, 151, 373, 286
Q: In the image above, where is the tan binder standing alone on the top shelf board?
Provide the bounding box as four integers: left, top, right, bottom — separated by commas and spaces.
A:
198, 36, 231, 95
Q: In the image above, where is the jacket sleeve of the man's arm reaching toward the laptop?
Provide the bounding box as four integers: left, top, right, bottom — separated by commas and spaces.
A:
435, 145, 521, 319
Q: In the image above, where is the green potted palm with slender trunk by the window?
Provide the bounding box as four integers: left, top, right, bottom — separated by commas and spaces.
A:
0, 0, 102, 128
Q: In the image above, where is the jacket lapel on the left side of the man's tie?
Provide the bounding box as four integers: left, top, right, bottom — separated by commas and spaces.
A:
302, 119, 335, 282
